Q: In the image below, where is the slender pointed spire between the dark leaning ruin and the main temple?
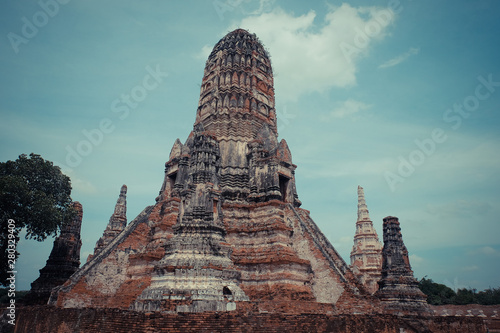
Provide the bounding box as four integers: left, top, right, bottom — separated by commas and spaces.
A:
87, 185, 127, 261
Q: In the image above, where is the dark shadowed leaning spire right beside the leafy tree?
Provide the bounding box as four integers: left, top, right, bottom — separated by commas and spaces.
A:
26, 201, 83, 304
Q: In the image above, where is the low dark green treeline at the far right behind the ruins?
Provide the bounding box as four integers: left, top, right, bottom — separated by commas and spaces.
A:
419, 277, 500, 305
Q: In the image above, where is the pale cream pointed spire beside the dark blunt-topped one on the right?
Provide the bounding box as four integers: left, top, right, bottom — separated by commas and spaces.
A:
350, 186, 382, 294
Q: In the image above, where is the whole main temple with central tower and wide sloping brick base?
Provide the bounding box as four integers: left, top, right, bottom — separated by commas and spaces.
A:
50, 29, 378, 313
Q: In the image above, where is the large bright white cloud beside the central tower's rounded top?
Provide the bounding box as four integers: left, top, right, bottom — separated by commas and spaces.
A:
226, 4, 395, 101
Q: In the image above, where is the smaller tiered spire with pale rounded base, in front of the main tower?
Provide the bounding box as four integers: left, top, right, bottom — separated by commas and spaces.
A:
131, 124, 249, 312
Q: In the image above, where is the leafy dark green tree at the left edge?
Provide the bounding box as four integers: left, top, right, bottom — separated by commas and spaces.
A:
0, 153, 74, 285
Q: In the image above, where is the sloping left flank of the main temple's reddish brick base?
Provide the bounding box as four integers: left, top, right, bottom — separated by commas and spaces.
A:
49, 207, 159, 309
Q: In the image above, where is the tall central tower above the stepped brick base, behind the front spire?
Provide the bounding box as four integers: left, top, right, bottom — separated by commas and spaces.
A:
195, 29, 299, 205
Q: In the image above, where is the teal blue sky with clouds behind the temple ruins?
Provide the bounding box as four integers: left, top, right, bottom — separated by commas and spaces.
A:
0, 0, 500, 290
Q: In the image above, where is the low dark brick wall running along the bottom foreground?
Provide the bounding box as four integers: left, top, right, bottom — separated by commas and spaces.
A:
10, 306, 486, 333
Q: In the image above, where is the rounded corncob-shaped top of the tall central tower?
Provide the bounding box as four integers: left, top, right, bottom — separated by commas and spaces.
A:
196, 29, 277, 140
